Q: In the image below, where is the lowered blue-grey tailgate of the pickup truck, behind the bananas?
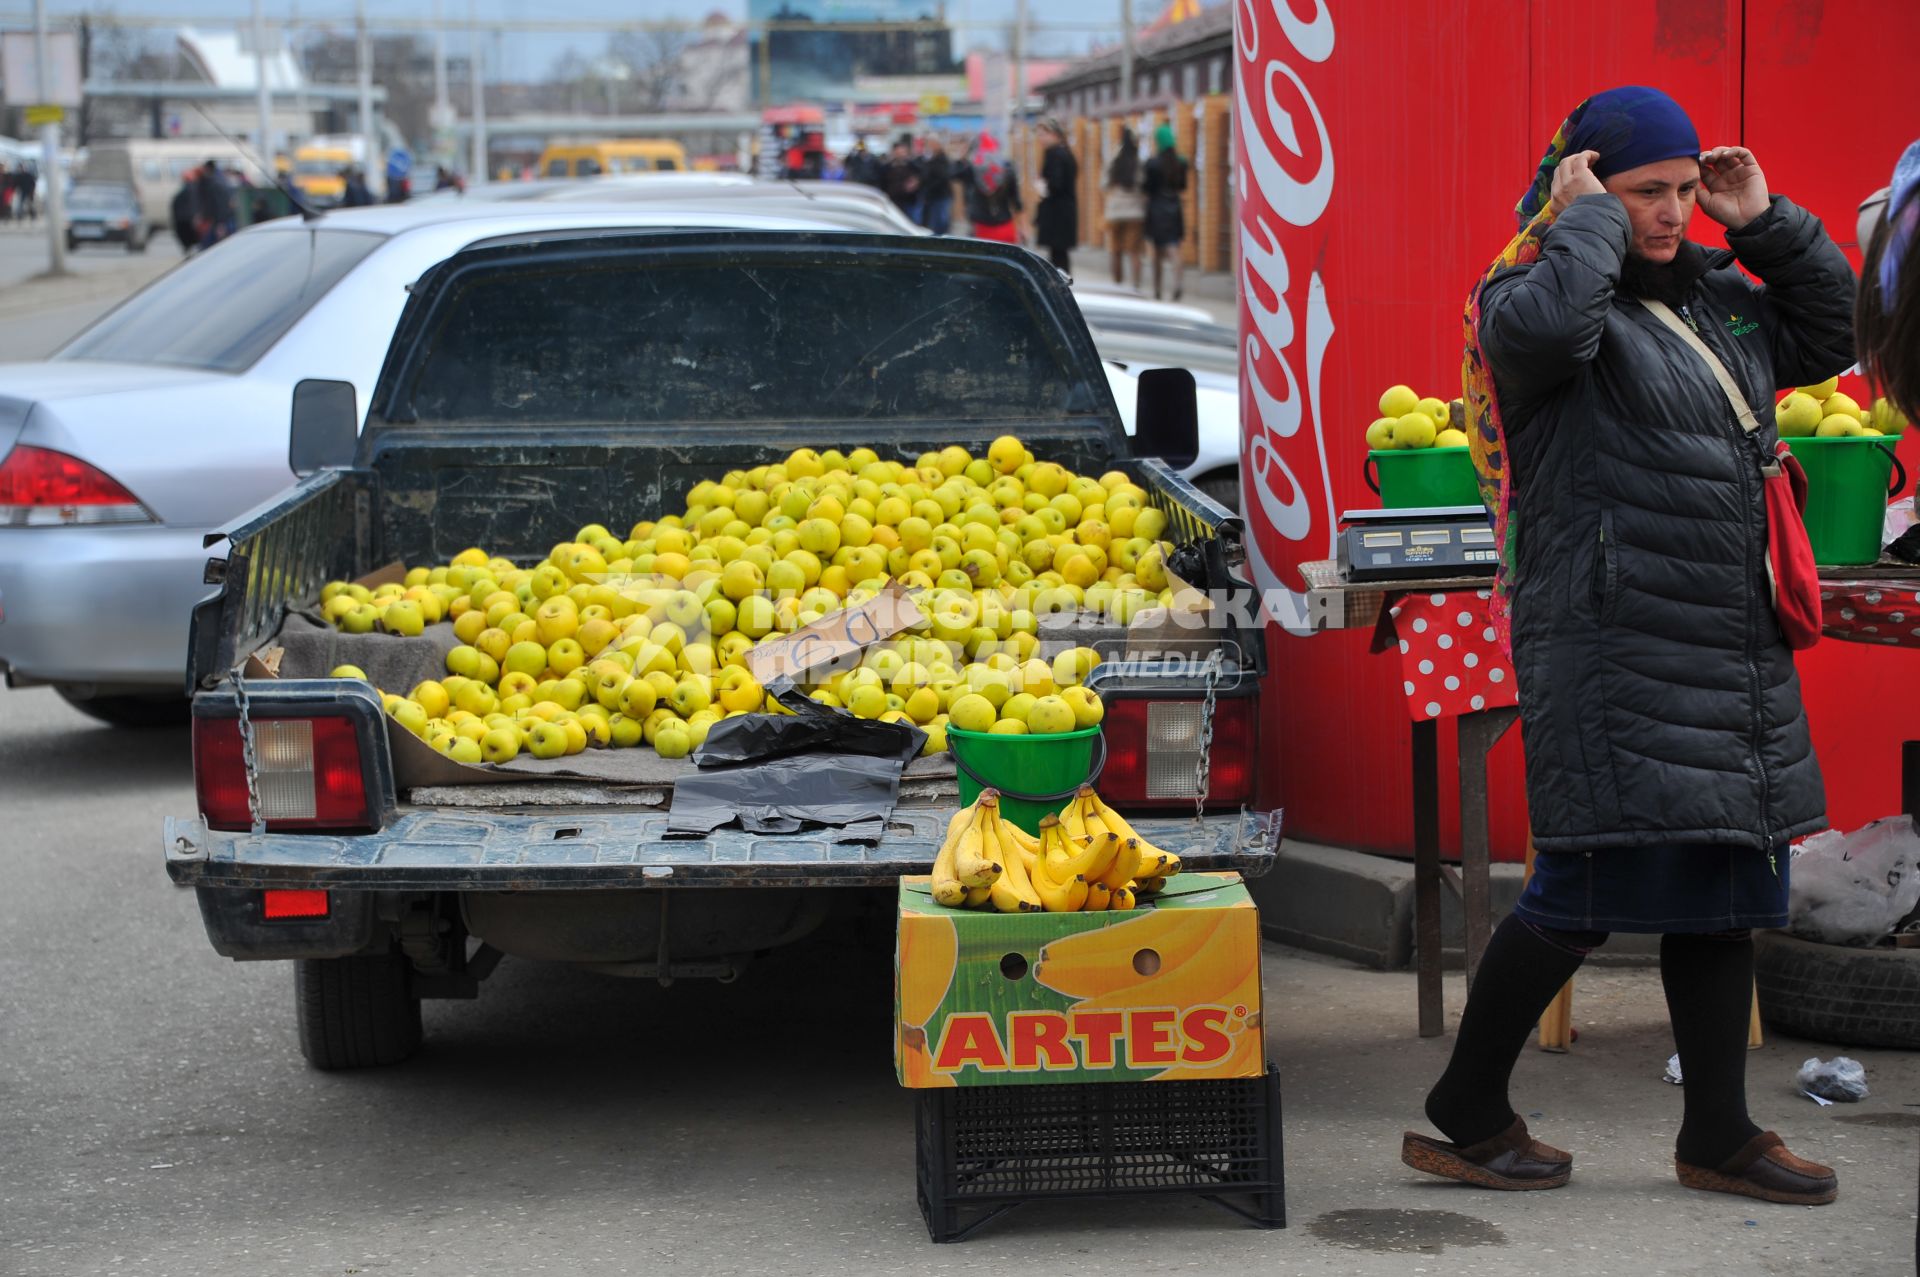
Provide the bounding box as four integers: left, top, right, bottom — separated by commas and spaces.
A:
165, 807, 1281, 891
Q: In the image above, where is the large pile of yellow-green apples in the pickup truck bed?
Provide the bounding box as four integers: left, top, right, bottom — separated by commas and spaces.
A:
309, 436, 1173, 762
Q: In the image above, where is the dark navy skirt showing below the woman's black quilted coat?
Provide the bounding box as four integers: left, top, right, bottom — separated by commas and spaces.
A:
1513, 843, 1788, 933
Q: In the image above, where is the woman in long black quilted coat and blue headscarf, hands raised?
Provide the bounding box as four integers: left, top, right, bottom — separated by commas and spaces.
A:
1402, 86, 1853, 1206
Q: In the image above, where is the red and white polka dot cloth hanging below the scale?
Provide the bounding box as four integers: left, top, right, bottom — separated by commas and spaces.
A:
1380, 590, 1519, 722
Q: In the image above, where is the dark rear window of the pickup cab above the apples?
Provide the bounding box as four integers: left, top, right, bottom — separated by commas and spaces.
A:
390, 253, 1106, 424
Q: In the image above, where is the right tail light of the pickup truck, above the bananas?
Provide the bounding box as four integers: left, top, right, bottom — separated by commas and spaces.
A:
1100, 697, 1260, 807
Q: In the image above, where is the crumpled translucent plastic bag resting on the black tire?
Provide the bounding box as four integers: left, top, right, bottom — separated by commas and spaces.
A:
1788, 816, 1920, 945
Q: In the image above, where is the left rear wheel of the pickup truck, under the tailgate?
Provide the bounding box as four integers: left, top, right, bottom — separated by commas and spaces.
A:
294, 954, 420, 1070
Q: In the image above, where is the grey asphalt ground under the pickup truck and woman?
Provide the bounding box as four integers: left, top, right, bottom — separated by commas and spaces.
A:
0, 672, 1920, 1277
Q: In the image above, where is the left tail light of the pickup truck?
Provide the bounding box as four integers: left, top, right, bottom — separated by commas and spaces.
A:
194, 718, 374, 830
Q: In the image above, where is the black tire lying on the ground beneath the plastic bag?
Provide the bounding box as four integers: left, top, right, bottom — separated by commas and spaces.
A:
1753, 931, 1920, 1050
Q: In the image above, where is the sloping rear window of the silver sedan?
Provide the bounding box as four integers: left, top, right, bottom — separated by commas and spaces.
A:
54, 229, 386, 373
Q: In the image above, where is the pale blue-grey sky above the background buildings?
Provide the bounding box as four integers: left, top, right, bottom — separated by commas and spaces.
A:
37, 0, 1128, 79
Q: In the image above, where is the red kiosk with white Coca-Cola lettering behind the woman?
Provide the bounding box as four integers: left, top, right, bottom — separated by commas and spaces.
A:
1233, 0, 1920, 860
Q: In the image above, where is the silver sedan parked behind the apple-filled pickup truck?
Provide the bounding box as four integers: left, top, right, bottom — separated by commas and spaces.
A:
0, 196, 1238, 724
